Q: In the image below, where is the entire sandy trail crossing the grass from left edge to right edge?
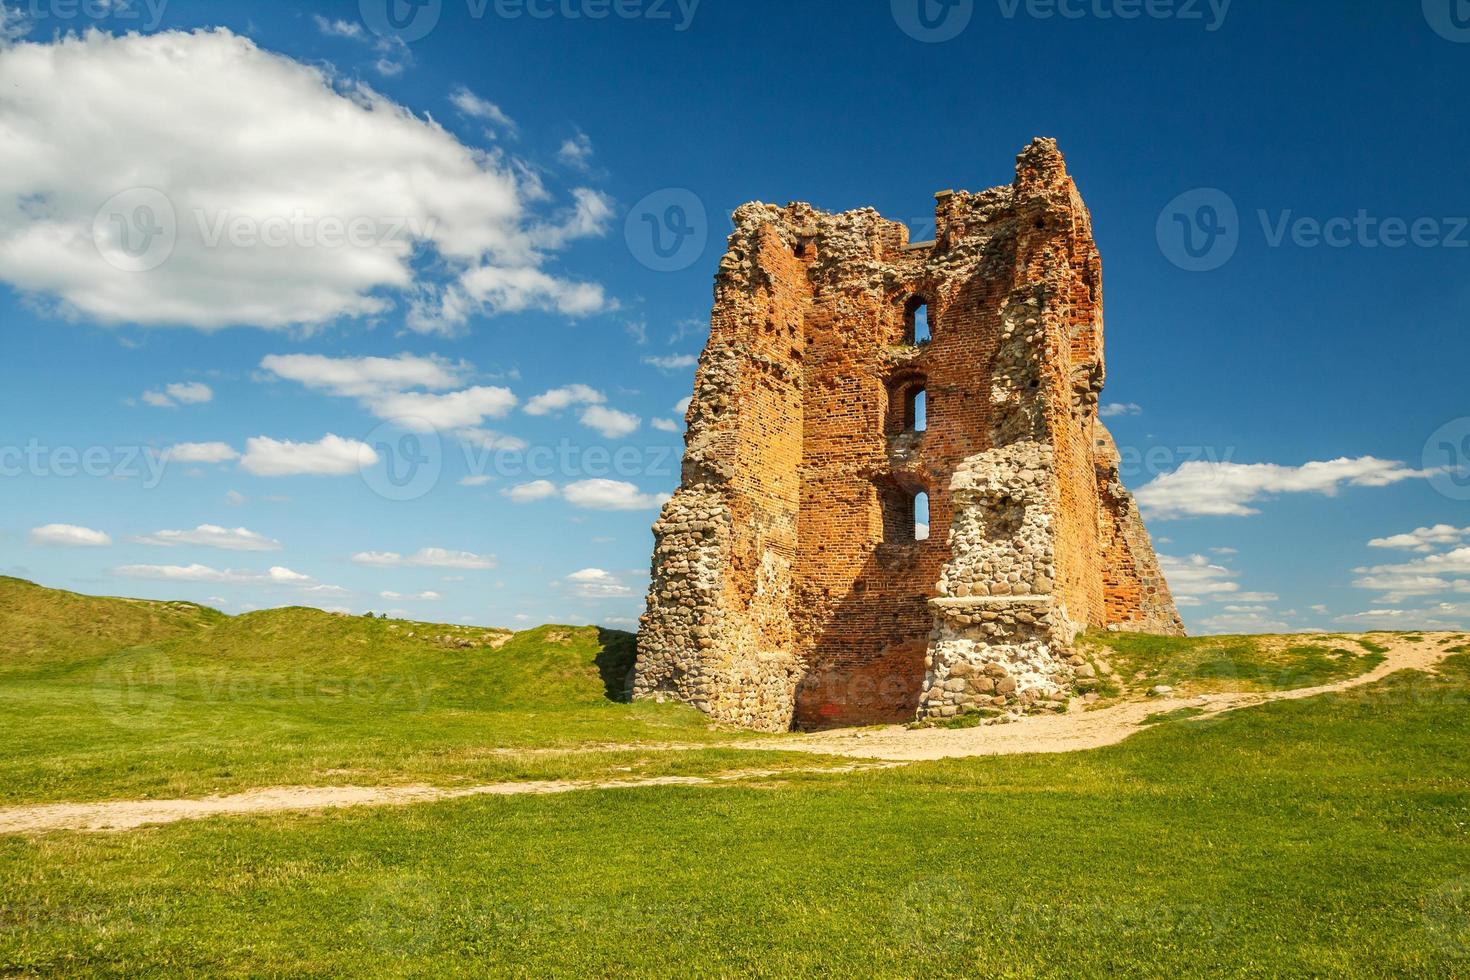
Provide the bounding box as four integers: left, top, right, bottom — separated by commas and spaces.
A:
0, 633, 1464, 835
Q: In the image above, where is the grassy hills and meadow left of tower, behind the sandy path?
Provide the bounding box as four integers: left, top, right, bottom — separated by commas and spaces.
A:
0, 579, 735, 804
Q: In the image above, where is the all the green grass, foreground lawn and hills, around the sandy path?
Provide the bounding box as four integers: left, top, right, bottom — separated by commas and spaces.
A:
0, 580, 1470, 977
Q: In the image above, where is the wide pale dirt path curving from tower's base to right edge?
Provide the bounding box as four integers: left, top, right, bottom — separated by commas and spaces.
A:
739, 633, 1463, 763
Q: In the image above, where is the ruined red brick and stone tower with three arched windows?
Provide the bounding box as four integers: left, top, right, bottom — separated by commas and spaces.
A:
634, 140, 1183, 730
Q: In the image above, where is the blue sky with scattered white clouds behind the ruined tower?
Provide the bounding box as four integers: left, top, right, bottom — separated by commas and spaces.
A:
0, 0, 1470, 632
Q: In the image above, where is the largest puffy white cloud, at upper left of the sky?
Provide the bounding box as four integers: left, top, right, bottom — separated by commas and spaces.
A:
0, 29, 613, 332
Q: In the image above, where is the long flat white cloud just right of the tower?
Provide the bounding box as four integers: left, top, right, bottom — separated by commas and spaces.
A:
1136, 455, 1430, 519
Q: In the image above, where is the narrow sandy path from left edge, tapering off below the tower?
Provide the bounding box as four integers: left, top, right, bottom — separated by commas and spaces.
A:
0, 763, 895, 835
